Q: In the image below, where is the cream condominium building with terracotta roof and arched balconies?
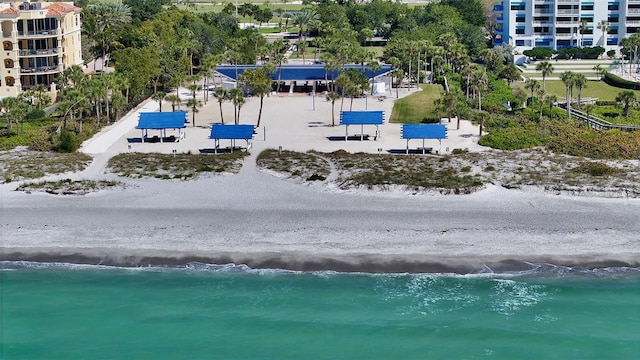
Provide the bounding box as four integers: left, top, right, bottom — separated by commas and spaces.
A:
0, 1, 82, 98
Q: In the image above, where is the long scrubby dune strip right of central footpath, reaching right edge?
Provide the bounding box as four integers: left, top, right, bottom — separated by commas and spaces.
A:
258, 148, 640, 196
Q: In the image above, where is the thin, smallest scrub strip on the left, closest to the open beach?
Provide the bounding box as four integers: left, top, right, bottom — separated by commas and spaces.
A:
16, 179, 124, 195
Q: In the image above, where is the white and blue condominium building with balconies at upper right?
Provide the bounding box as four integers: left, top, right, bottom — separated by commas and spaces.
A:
493, 0, 640, 51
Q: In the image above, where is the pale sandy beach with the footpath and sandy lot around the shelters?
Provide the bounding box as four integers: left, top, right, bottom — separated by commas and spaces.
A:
0, 90, 640, 273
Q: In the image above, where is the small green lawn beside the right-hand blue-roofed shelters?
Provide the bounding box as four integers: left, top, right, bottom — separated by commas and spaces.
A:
389, 84, 442, 124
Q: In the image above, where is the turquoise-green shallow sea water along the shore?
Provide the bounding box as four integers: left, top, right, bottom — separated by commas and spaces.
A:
0, 263, 640, 359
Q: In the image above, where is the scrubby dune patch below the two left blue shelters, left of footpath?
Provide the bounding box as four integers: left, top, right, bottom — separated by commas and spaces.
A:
108, 151, 248, 180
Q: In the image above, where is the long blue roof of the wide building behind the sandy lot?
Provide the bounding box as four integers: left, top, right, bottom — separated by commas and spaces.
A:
216, 64, 391, 81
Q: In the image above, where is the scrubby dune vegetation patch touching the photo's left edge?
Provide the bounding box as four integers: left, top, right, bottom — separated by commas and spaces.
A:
0, 150, 92, 183
